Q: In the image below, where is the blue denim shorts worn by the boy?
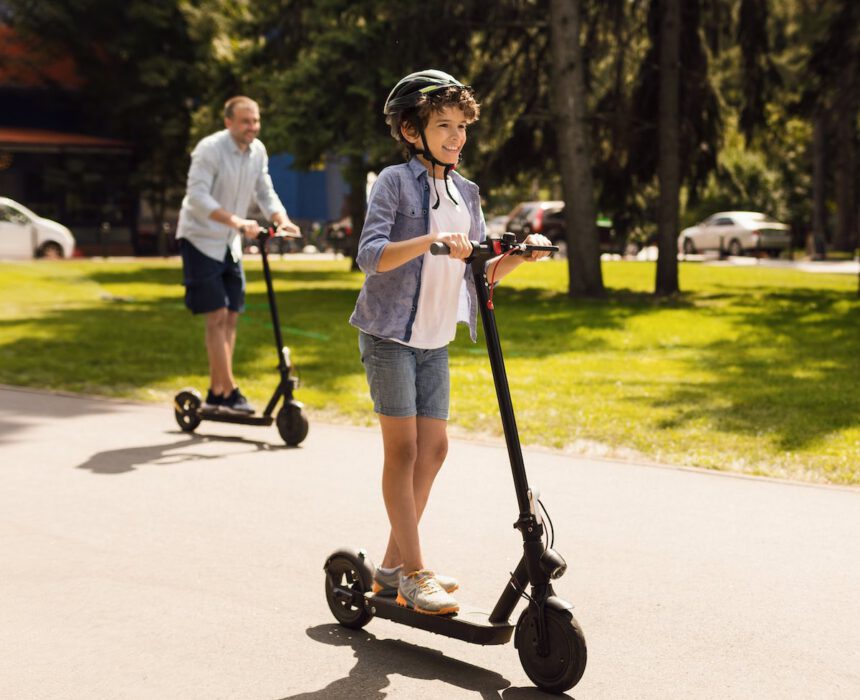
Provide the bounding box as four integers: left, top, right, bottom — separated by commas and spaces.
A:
358, 331, 451, 420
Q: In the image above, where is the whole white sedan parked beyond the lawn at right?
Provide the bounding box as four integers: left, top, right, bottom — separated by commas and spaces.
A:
678, 211, 791, 255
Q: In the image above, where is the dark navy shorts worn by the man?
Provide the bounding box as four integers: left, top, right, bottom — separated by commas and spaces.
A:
179, 238, 245, 314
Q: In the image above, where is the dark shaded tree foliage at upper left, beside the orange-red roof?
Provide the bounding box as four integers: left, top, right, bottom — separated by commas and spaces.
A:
8, 0, 215, 246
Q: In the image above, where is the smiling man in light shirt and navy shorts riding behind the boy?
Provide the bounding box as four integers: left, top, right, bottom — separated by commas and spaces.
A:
176, 96, 299, 414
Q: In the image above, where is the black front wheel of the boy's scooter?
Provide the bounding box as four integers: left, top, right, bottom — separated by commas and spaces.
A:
514, 605, 587, 693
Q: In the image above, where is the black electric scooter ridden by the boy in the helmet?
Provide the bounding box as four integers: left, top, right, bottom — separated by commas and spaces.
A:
323, 233, 587, 693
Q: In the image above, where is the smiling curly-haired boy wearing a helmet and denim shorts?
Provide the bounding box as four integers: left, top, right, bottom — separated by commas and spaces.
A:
350, 70, 549, 615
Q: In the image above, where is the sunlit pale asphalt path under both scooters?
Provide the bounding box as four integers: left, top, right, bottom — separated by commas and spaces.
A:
0, 387, 860, 700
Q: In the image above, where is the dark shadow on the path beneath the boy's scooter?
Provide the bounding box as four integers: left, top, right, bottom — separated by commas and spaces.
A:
282, 624, 570, 700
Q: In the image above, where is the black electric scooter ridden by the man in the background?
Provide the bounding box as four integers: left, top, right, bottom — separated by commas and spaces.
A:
173, 228, 308, 447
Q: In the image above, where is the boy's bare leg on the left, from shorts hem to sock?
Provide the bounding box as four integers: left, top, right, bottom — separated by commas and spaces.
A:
379, 414, 426, 571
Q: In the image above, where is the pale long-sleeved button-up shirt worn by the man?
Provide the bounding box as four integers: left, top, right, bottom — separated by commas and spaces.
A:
176, 129, 286, 260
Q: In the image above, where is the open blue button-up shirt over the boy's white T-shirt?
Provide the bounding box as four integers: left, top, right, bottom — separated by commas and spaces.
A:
349, 158, 487, 342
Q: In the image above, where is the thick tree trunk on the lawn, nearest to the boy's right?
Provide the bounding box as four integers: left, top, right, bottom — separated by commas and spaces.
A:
550, 0, 606, 297
